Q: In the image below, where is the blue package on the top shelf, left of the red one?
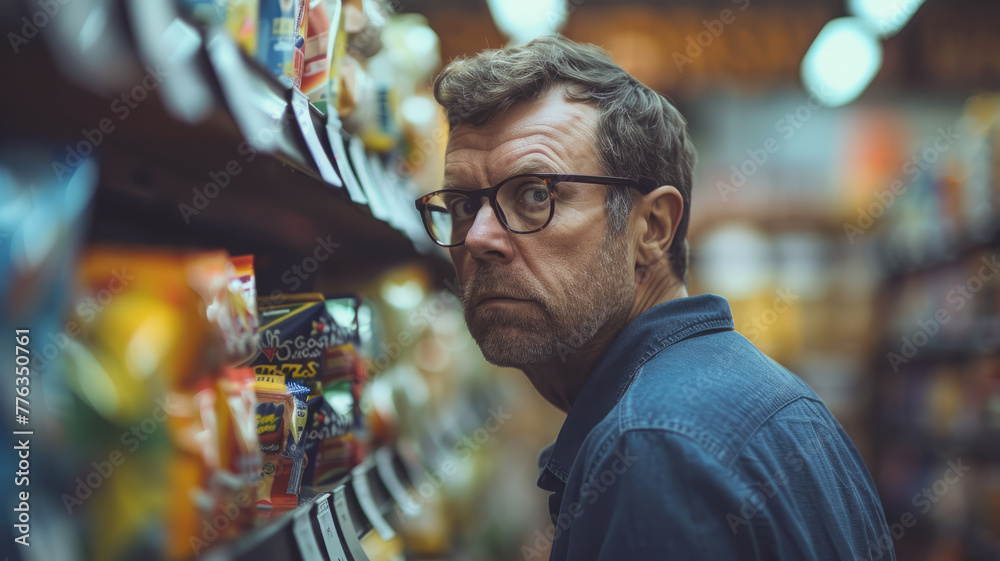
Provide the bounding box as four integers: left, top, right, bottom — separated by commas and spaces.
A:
257, 0, 294, 87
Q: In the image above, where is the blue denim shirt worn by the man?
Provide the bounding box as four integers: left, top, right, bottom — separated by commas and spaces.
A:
536, 294, 895, 561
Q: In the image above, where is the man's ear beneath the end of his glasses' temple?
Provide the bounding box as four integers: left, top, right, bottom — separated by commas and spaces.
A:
635, 185, 684, 267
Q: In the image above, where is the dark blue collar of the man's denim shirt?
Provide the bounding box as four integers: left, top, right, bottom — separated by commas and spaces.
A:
538, 294, 734, 491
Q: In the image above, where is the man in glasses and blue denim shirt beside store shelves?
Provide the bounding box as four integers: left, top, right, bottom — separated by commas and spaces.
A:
417, 38, 894, 560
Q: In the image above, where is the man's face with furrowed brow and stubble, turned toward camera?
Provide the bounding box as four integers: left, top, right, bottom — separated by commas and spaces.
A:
445, 88, 635, 368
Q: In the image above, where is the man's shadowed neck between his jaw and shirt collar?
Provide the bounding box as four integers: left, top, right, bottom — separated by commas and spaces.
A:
522, 278, 688, 413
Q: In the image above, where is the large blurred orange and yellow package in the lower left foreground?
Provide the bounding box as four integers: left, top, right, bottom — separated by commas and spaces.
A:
60, 247, 234, 559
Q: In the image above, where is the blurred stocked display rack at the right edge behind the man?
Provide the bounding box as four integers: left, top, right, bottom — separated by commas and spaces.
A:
869, 101, 1000, 561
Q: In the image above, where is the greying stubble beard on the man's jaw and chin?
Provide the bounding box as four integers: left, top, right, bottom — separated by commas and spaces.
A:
462, 234, 635, 370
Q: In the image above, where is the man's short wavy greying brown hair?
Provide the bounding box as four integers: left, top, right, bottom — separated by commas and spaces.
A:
434, 36, 696, 284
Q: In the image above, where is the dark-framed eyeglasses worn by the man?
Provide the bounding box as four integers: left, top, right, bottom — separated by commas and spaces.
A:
416, 173, 653, 247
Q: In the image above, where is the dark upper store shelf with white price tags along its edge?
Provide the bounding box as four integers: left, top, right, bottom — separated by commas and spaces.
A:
0, 0, 441, 276
